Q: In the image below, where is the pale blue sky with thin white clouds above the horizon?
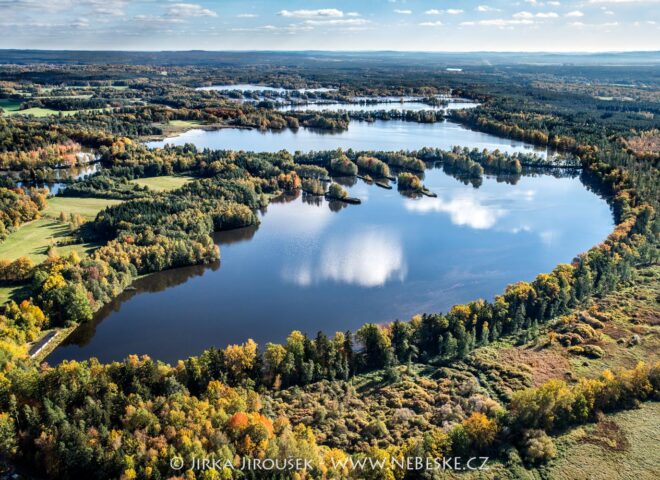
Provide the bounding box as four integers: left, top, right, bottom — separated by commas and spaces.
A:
0, 0, 660, 51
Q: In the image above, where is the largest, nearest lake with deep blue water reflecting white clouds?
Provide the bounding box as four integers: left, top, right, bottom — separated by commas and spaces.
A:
48, 165, 613, 364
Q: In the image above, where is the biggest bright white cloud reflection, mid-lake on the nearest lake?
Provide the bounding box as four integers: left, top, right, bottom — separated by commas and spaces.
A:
283, 229, 408, 288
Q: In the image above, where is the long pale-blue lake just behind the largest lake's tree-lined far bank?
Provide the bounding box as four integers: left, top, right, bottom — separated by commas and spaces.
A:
148, 120, 545, 154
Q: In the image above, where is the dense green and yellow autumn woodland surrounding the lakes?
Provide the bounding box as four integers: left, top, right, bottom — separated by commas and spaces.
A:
0, 60, 660, 479
